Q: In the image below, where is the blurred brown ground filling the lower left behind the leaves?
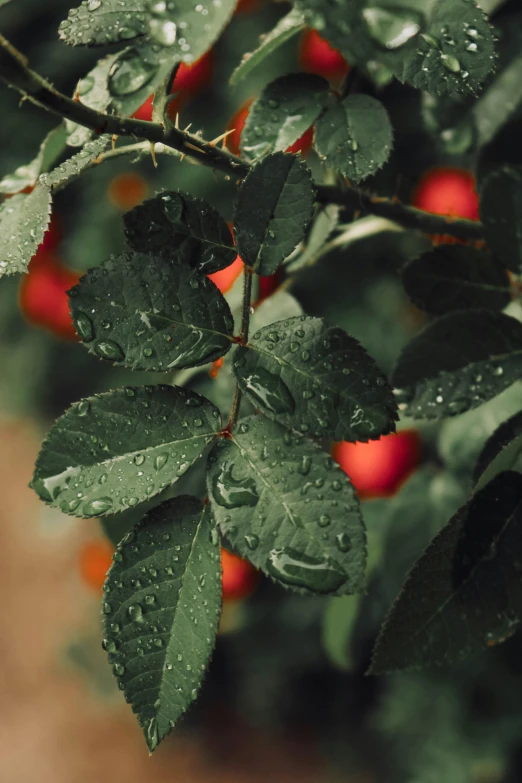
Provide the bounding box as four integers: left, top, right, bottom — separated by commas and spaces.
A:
0, 421, 338, 783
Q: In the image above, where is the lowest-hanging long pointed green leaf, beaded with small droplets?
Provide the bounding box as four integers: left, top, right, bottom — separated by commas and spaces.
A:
102, 495, 221, 753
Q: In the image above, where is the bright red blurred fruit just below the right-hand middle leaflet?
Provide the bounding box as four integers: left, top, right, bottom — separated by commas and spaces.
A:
332, 430, 421, 498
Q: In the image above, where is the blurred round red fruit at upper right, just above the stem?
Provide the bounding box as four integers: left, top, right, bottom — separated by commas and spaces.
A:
412, 168, 479, 220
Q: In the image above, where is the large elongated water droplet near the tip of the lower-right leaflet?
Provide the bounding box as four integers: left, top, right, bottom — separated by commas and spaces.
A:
267, 547, 346, 594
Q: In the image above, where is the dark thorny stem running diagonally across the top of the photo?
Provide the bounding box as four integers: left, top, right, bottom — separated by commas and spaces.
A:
0, 34, 483, 241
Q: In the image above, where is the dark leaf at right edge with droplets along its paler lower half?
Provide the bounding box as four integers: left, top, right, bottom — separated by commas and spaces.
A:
392, 310, 522, 419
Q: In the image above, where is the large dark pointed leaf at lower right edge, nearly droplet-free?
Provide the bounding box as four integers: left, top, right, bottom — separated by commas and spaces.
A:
370, 473, 522, 674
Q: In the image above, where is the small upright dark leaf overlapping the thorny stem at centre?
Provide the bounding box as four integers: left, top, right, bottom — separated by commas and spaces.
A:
234, 152, 314, 275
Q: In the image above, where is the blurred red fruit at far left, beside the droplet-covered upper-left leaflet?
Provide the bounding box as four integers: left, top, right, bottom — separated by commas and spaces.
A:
19, 255, 80, 340
